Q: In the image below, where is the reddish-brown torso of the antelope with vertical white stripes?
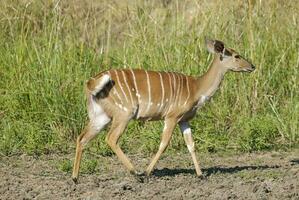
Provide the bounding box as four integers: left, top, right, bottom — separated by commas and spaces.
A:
90, 69, 195, 119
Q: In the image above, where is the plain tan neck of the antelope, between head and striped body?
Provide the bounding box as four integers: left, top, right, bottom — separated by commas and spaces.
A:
196, 55, 227, 99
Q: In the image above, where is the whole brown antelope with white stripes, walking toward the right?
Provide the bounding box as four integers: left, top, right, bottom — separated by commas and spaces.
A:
72, 39, 255, 182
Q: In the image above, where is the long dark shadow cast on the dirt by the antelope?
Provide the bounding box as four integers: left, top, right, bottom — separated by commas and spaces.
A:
153, 165, 282, 177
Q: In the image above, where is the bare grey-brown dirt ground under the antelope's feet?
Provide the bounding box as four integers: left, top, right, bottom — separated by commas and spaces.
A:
0, 150, 299, 199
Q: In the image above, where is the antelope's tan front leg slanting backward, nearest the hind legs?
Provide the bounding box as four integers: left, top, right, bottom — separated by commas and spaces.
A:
146, 119, 176, 176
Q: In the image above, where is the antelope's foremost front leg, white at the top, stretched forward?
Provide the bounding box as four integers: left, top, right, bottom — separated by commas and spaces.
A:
179, 122, 202, 176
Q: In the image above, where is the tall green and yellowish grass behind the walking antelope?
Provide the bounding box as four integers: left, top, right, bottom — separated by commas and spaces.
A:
0, 0, 299, 156
